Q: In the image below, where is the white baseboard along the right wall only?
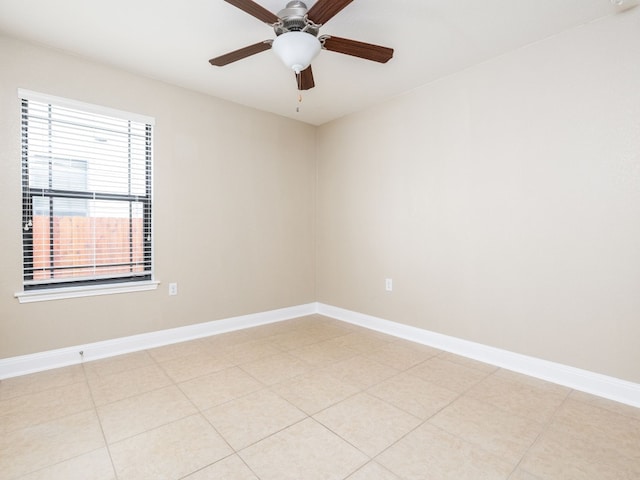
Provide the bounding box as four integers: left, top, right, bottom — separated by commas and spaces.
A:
317, 303, 640, 408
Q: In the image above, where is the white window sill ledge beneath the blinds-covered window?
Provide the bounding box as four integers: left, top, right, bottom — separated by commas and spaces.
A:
15, 280, 160, 303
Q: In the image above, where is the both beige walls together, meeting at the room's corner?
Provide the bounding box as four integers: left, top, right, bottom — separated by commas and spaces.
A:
0, 9, 640, 382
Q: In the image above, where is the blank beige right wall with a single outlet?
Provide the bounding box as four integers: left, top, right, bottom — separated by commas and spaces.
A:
316, 9, 640, 382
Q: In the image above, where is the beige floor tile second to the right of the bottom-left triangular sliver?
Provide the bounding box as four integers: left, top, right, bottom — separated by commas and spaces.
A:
204, 390, 306, 450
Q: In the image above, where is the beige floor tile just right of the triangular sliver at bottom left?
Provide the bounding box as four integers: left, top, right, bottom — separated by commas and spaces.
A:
110, 415, 233, 480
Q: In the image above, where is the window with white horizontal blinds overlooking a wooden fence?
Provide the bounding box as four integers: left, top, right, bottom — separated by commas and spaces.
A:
19, 90, 153, 292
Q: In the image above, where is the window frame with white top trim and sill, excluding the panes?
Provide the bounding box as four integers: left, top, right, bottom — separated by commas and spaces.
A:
15, 89, 159, 303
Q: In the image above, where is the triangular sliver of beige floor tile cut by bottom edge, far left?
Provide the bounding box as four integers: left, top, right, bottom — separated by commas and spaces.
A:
20, 448, 116, 480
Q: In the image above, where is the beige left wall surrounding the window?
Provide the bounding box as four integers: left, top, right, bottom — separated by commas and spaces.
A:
0, 37, 315, 358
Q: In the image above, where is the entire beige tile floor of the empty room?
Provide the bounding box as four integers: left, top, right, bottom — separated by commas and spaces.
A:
0, 316, 640, 480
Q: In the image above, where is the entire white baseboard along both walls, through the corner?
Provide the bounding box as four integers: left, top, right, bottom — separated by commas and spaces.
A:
0, 303, 640, 408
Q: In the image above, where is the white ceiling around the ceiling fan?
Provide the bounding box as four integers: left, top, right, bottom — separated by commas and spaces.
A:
0, 0, 634, 125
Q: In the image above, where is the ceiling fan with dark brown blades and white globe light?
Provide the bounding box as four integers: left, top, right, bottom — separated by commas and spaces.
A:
209, 0, 393, 90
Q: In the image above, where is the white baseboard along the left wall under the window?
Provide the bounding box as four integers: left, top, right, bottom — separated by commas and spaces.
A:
0, 303, 317, 379
